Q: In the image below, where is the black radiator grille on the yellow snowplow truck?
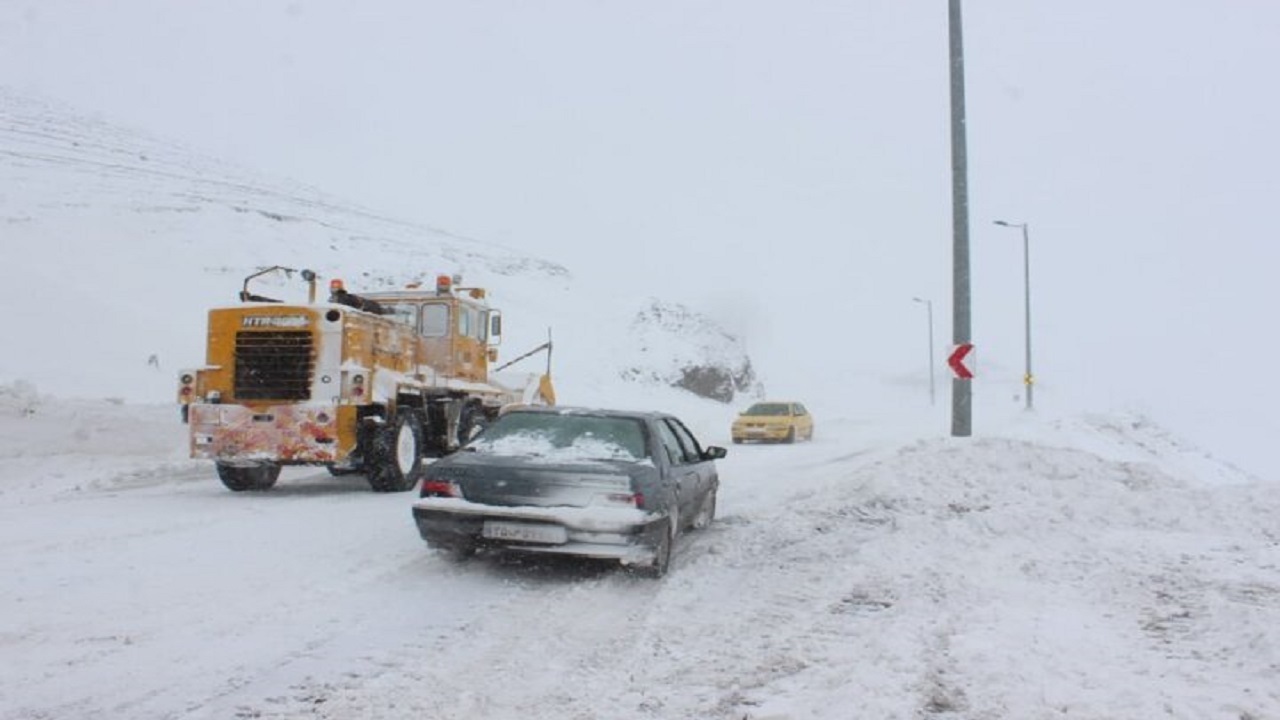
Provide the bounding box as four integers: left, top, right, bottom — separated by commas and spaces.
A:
236, 331, 315, 400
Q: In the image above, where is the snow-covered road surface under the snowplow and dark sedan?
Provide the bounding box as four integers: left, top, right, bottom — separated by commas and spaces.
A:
0, 397, 896, 717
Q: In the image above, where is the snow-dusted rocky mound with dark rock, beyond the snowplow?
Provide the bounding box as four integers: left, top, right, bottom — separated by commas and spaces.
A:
621, 299, 762, 402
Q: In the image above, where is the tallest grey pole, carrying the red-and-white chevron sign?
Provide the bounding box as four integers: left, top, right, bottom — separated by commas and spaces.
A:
948, 0, 973, 437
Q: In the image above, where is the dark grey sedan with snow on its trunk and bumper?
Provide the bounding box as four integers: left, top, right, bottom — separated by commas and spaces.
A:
413, 407, 724, 578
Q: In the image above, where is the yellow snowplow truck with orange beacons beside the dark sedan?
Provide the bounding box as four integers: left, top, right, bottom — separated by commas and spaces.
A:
178, 266, 556, 492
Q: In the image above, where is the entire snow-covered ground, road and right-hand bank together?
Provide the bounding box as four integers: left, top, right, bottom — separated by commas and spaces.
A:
0, 404, 1280, 720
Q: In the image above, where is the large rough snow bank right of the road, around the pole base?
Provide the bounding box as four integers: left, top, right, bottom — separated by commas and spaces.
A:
707, 434, 1280, 717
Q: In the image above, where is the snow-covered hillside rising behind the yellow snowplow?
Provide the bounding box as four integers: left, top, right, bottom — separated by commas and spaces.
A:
0, 87, 748, 402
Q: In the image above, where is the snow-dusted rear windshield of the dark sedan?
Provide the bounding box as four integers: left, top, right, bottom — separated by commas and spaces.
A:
471, 413, 649, 461
